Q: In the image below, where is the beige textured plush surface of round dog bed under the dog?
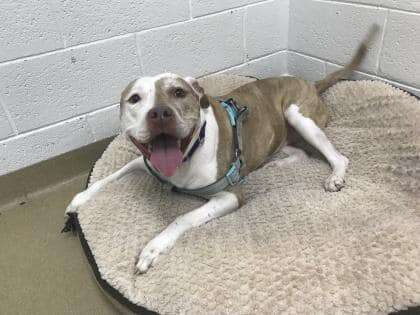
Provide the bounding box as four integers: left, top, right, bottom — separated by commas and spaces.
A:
70, 76, 420, 314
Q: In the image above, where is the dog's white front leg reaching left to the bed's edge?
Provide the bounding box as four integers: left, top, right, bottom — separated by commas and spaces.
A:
66, 157, 145, 215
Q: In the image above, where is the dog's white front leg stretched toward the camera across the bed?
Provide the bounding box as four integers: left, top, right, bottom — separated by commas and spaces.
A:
136, 191, 239, 273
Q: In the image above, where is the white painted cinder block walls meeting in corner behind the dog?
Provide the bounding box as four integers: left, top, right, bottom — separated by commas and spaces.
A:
0, 0, 420, 175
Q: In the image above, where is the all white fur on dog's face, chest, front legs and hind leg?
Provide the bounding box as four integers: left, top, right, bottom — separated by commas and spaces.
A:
66, 78, 348, 273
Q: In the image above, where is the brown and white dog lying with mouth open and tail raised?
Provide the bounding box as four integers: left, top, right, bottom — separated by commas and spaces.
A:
66, 25, 379, 273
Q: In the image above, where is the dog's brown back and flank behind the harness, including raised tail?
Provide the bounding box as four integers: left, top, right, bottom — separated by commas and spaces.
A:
218, 24, 379, 173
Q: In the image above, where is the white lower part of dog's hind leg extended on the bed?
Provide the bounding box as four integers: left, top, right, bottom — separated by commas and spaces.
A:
284, 104, 349, 191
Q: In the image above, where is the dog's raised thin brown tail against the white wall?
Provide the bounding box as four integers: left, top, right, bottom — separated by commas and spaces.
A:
315, 23, 380, 93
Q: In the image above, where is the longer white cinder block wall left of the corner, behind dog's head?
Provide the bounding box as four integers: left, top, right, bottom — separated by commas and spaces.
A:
0, 0, 289, 175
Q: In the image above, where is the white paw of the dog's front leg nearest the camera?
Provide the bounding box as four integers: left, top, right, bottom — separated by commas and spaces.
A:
135, 234, 175, 274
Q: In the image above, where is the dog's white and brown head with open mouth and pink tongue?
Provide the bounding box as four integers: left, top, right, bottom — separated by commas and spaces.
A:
120, 73, 209, 177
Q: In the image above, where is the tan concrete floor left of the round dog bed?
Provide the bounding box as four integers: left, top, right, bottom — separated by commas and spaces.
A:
0, 174, 119, 315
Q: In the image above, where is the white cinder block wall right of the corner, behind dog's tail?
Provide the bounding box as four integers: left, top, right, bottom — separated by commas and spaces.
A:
288, 0, 420, 96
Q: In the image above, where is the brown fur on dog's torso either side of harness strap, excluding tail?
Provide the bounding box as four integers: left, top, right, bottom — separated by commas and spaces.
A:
212, 77, 328, 177
